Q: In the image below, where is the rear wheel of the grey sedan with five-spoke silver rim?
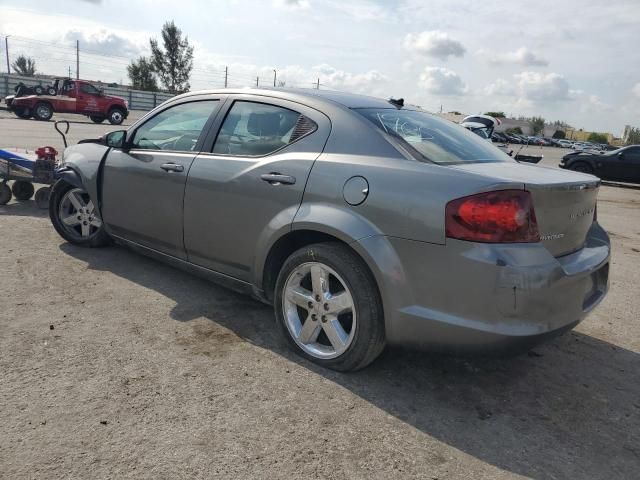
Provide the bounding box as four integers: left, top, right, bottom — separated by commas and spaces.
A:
274, 242, 385, 372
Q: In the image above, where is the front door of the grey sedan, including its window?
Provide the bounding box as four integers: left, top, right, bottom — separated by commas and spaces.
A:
102, 96, 222, 259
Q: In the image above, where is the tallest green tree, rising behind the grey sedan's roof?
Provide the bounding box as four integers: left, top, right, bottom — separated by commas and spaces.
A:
149, 20, 193, 93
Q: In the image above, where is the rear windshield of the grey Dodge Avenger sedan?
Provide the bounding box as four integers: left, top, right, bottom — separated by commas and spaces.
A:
355, 108, 515, 165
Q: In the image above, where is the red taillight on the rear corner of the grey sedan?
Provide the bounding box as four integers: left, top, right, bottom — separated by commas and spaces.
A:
445, 190, 540, 243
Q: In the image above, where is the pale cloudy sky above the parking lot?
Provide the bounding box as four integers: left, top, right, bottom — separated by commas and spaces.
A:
0, 0, 640, 136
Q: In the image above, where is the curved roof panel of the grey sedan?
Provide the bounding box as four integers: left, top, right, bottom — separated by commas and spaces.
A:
170, 87, 410, 109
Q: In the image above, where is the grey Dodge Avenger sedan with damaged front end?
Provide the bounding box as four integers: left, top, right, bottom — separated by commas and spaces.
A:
50, 89, 610, 371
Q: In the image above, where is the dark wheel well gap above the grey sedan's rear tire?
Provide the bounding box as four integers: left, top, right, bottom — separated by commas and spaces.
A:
262, 230, 352, 301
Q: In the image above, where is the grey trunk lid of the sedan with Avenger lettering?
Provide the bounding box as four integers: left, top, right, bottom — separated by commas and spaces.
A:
451, 162, 600, 257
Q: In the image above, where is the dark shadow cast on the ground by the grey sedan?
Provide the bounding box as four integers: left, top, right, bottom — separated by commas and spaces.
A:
60, 244, 640, 479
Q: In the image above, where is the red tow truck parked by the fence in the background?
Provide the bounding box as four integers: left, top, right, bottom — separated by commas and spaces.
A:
5, 79, 129, 125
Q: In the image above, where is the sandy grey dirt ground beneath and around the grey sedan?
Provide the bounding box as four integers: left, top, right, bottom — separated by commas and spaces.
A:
0, 119, 640, 479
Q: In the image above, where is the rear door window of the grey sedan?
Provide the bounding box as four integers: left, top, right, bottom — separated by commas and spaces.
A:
213, 101, 317, 157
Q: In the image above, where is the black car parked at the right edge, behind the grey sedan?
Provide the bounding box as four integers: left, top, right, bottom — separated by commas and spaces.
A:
560, 145, 640, 183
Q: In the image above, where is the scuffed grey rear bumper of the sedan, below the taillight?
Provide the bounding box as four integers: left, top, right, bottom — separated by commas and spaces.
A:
360, 224, 610, 351
